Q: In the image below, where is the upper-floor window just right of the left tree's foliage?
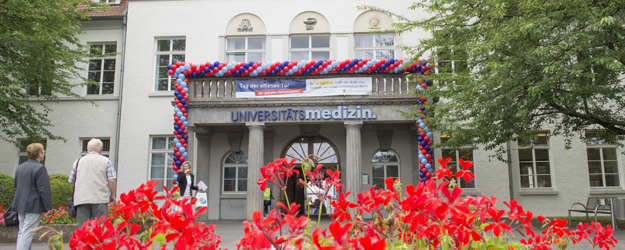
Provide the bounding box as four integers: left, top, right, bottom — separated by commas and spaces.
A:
87, 44, 117, 95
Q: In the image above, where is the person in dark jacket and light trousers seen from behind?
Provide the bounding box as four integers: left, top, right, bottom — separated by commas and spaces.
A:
11, 143, 52, 250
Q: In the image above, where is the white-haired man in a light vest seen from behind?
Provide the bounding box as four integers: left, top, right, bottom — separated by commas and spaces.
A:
69, 139, 117, 228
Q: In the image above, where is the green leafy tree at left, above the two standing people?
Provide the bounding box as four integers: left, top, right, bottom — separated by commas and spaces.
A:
0, 0, 105, 142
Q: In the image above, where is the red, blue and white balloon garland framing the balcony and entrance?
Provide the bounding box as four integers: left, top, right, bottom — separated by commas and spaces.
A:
167, 59, 434, 187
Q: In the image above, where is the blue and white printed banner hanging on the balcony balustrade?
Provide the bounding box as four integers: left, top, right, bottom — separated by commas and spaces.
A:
236, 77, 372, 98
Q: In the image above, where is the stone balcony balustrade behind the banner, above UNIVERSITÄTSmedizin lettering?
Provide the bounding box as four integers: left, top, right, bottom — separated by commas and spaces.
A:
189, 74, 414, 102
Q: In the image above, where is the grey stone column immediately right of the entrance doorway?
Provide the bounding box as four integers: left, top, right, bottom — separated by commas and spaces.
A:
344, 121, 362, 203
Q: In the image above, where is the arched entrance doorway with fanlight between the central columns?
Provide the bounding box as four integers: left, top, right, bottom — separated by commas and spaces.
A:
280, 136, 340, 215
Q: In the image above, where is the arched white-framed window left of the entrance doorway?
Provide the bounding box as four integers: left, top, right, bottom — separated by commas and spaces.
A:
223, 152, 247, 193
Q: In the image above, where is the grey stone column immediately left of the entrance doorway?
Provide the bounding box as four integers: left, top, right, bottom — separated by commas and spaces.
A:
245, 122, 265, 221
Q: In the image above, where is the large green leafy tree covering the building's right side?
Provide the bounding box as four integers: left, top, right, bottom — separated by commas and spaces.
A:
363, 0, 625, 155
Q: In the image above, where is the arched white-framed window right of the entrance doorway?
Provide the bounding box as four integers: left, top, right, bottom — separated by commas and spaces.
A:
371, 151, 399, 189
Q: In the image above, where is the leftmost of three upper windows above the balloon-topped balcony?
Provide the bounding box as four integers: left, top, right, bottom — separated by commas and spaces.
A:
226, 37, 266, 62
